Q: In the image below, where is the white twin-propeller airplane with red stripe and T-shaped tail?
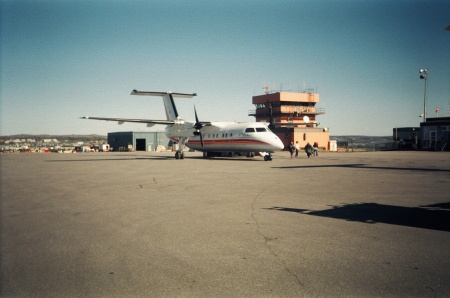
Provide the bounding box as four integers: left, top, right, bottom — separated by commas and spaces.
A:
81, 90, 284, 161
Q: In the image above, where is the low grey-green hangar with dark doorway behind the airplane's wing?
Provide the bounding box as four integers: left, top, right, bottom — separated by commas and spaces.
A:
108, 131, 172, 151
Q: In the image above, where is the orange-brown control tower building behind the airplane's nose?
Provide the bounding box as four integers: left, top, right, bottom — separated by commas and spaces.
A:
249, 91, 330, 150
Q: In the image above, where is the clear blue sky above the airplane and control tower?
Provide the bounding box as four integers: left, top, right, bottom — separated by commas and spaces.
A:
0, 0, 450, 136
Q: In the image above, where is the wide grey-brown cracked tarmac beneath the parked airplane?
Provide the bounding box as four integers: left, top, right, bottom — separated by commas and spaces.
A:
0, 151, 450, 297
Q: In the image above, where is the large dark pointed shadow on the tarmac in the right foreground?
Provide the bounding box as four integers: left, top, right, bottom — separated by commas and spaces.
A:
264, 202, 450, 232
